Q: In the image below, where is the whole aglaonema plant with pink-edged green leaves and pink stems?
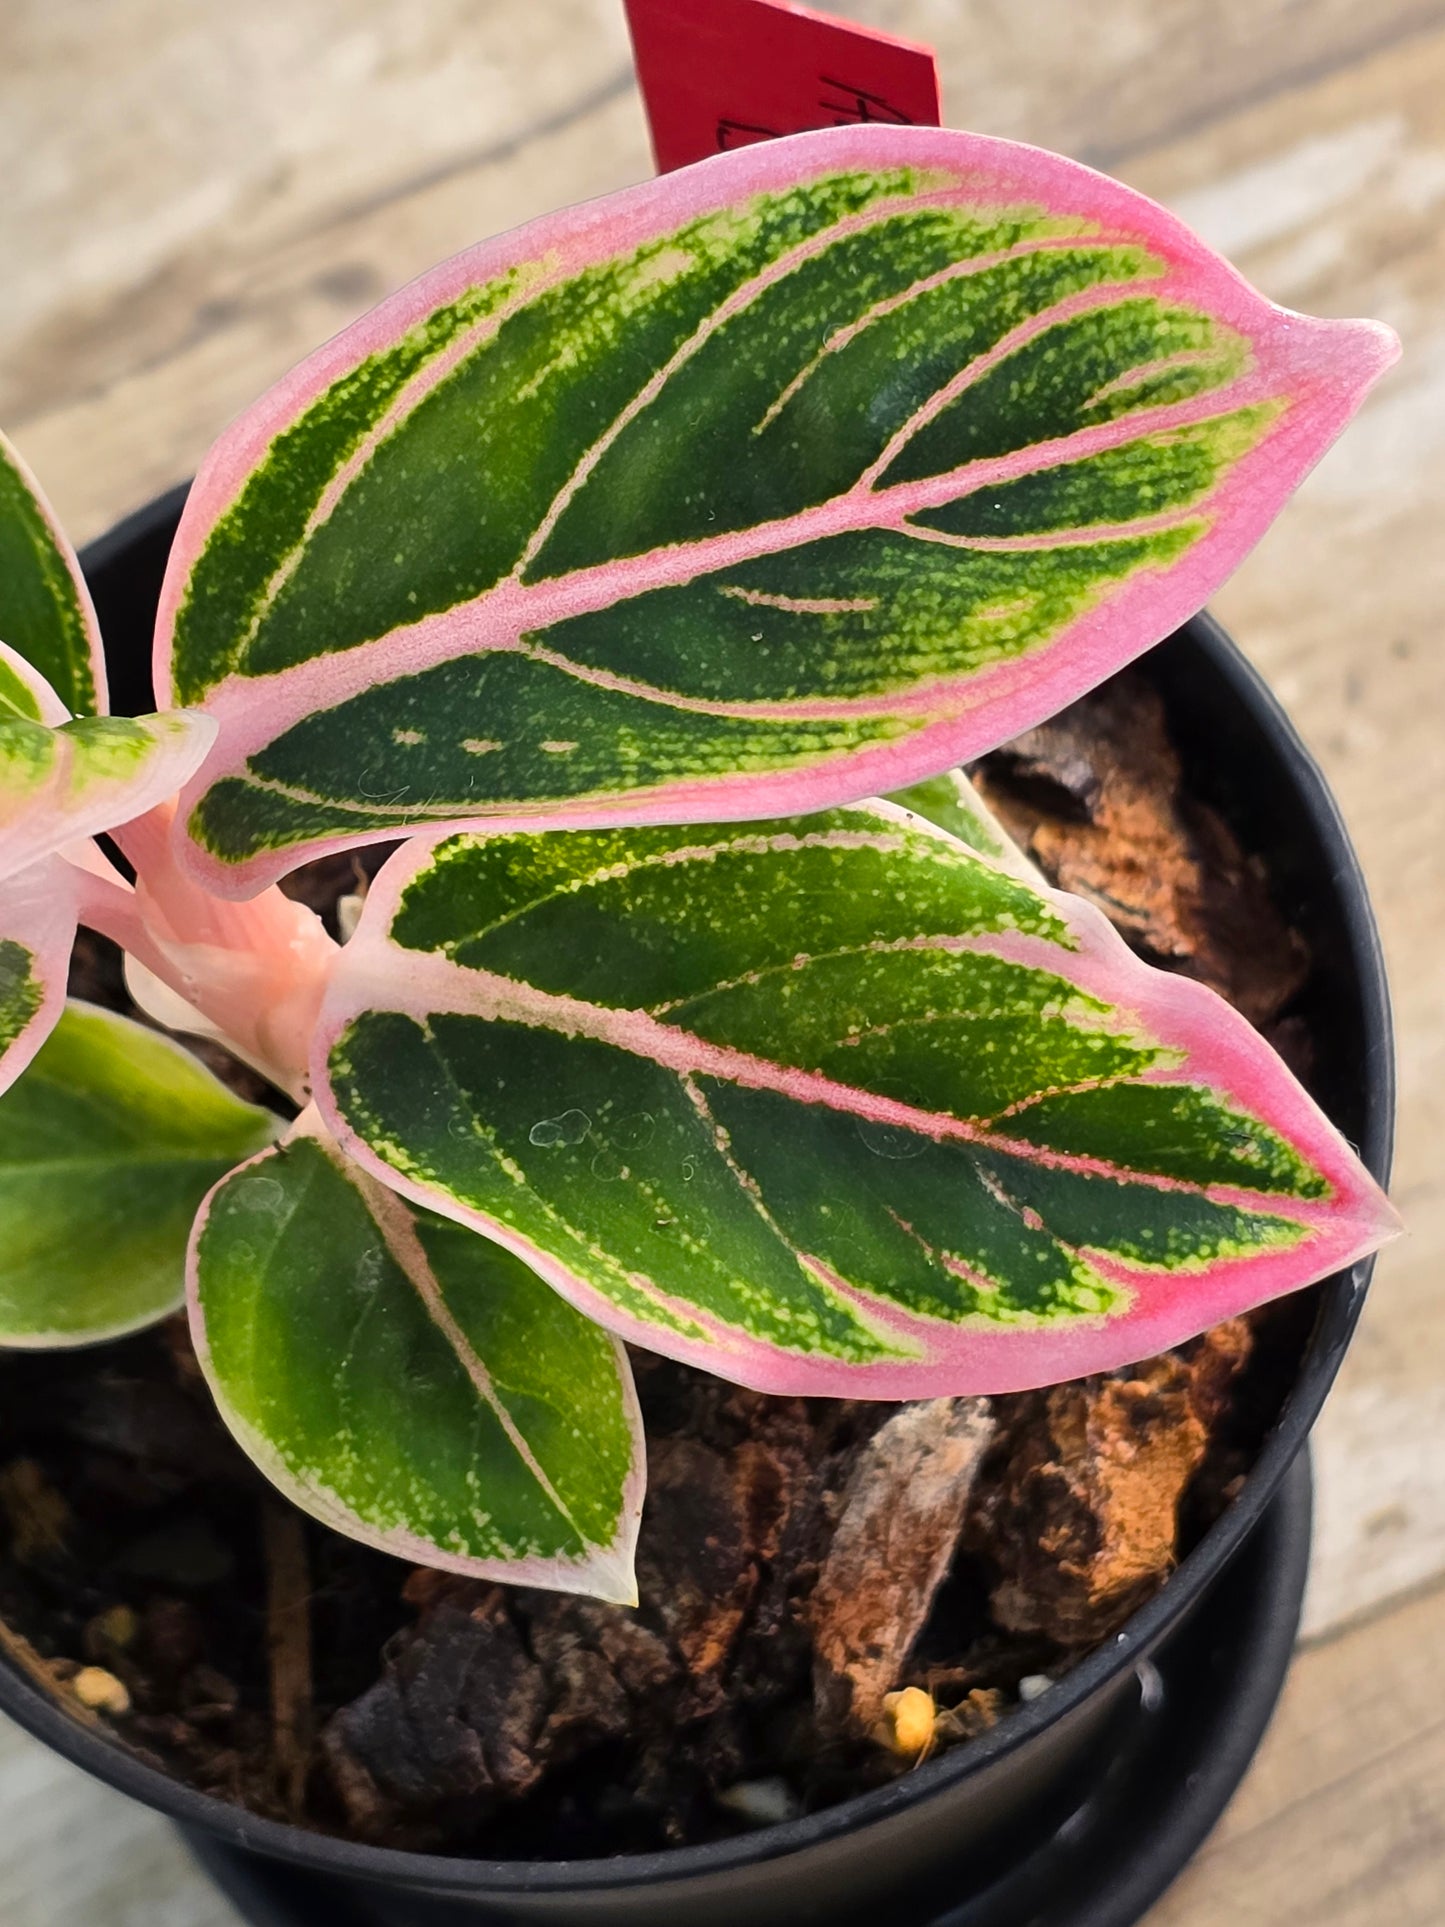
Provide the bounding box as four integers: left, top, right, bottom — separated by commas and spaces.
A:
0, 127, 1395, 1599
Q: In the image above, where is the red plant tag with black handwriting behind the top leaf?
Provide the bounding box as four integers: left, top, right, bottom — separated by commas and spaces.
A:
626, 0, 940, 173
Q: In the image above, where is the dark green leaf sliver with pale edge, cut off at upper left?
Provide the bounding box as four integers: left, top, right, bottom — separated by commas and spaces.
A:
0, 436, 106, 721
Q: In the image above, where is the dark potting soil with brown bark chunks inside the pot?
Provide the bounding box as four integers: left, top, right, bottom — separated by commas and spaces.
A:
0, 673, 1314, 1860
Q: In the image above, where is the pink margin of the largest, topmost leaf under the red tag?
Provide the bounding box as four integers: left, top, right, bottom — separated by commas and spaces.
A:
156, 125, 1399, 896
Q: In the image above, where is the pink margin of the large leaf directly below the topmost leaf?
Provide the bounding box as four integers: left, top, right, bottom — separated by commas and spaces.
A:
312, 804, 1401, 1399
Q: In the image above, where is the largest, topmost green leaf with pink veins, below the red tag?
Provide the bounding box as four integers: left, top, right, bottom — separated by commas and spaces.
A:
158, 125, 1395, 894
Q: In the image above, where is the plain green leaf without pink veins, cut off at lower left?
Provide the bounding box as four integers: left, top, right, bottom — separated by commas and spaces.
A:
0, 1002, 277, 1349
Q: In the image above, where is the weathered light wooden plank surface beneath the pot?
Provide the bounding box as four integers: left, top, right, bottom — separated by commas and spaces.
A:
0, 0, 1445, 1927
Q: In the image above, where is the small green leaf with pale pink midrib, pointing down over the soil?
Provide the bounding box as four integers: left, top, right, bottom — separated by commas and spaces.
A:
191, 1112, 644, 1603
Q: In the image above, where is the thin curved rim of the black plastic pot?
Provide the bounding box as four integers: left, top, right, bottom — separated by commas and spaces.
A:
0, 516, 1395, 1896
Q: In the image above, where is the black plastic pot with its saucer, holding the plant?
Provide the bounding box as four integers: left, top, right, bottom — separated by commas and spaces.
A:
0, 491, 1393, 1927
